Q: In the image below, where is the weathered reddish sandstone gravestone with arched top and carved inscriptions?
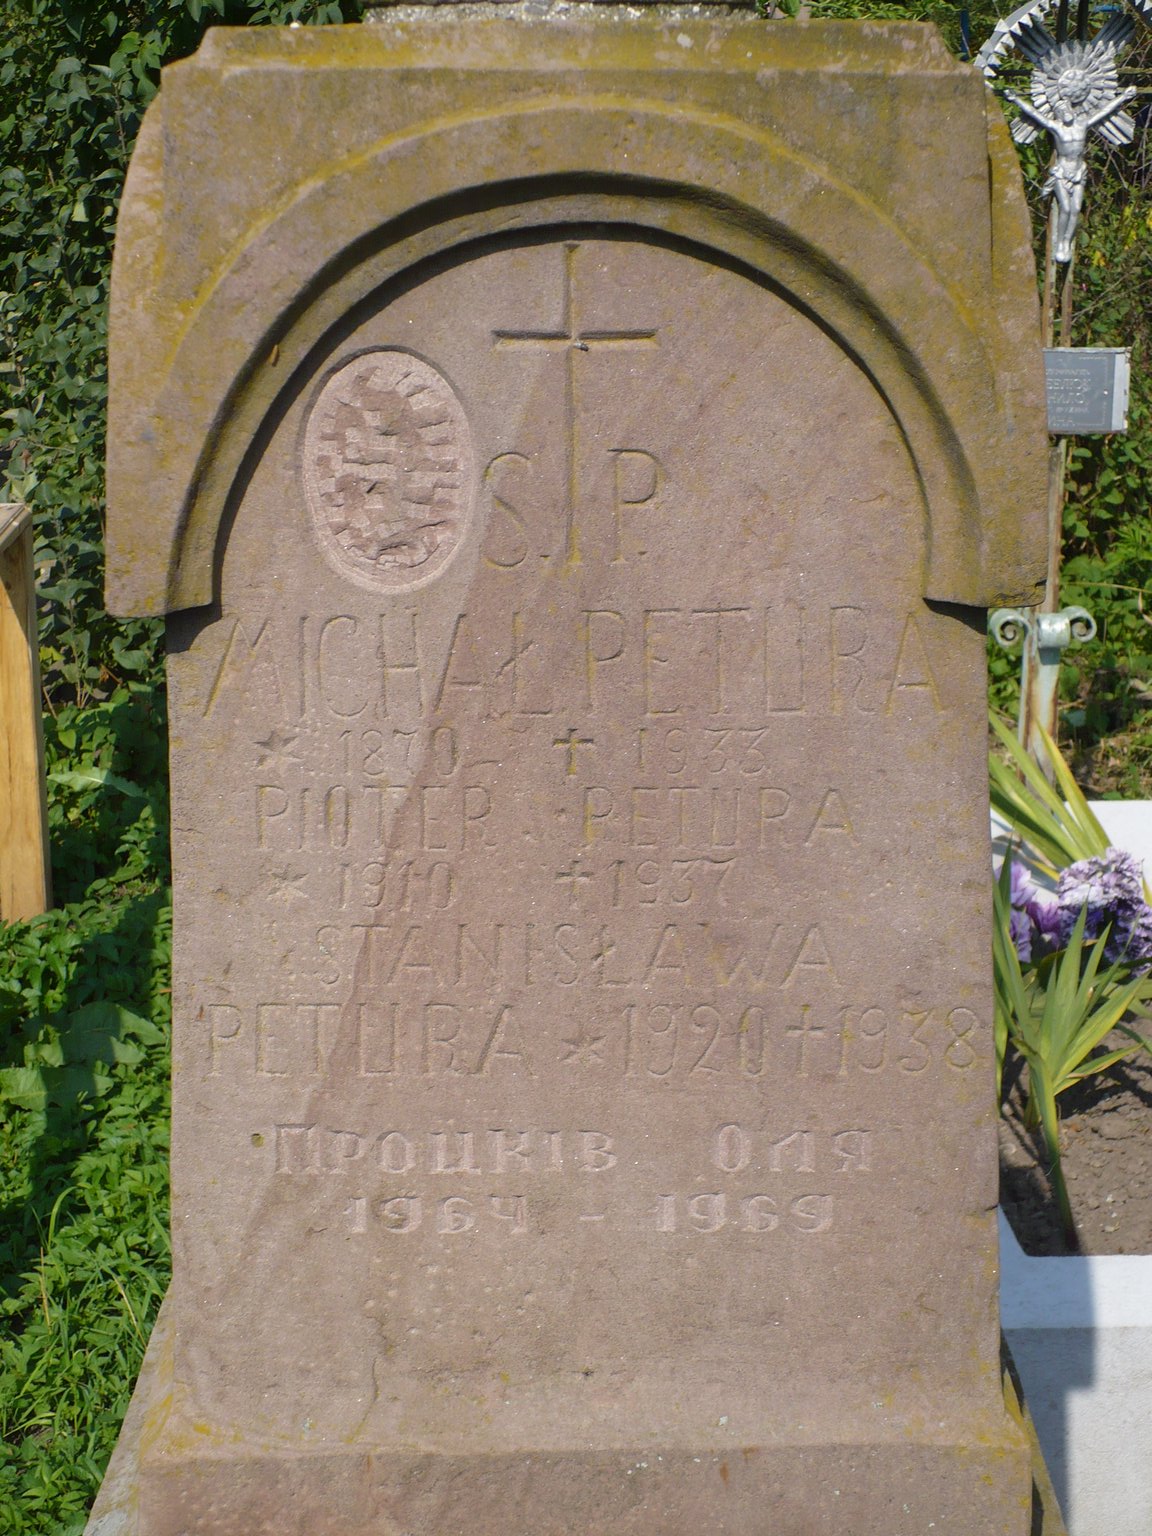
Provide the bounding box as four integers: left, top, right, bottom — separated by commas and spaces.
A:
97, 6, 1044, 1536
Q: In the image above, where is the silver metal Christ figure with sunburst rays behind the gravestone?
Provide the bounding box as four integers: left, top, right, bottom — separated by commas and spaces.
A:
975, 0, 1152, 263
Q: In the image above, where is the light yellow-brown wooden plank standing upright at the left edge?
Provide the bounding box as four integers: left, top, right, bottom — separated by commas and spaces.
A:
0, 502, 52, 922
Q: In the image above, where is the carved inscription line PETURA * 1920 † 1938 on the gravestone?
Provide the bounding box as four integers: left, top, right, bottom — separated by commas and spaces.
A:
201, 989, 992, 1092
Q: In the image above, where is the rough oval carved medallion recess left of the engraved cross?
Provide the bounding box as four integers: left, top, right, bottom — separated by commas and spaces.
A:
304, 347, 476, 591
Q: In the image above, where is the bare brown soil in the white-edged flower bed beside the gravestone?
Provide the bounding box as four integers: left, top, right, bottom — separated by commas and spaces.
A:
1000, 1054, 1152, 1253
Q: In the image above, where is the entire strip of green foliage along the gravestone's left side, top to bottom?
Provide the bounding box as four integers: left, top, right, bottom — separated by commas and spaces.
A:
0, 0, 352, 1536
